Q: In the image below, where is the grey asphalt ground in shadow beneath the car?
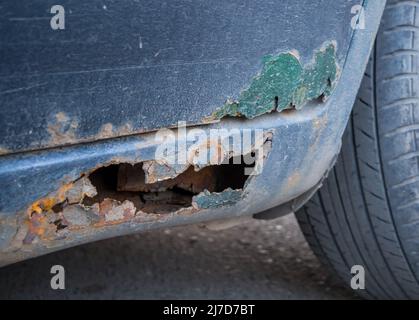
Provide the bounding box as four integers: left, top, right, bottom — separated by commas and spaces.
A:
0, 215, 355, 299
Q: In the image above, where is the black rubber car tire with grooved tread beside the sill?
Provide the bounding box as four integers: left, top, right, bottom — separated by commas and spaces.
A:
296, 0, 419, 299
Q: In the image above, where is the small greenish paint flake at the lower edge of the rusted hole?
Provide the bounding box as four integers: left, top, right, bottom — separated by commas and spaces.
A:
192, 188, 242, 209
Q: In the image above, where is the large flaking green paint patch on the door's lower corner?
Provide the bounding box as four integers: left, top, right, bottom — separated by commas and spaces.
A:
210, 43, 338, 119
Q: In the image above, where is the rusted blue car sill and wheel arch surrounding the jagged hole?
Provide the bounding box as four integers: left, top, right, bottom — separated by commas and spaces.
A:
0, 1, 385, 265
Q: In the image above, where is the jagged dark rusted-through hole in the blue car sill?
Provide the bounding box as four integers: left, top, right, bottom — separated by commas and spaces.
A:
83, 156, 255, 213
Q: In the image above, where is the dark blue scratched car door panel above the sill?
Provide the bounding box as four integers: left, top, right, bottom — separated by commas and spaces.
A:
0, 0, 362, 154
